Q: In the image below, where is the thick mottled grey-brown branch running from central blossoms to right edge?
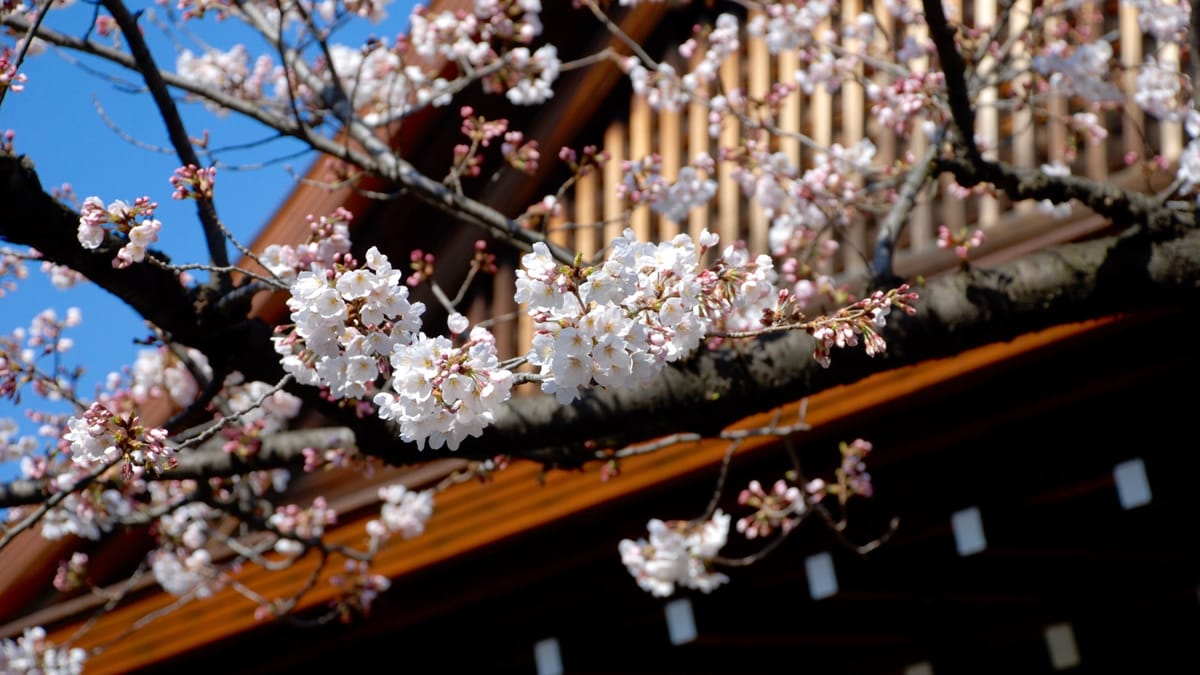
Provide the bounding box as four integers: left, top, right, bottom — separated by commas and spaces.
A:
448, 223, 1200, 466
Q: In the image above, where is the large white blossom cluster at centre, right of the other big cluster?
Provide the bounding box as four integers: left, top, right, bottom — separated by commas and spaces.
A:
515, 229, 774, 404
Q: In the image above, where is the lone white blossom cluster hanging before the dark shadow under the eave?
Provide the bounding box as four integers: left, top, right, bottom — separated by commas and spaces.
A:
618, 509, 730, 597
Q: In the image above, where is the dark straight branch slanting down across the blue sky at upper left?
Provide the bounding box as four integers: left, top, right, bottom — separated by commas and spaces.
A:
102, 0, 229, 271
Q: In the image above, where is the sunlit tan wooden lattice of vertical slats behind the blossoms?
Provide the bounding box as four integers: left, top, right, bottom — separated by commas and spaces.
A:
494, 0, 1184, 362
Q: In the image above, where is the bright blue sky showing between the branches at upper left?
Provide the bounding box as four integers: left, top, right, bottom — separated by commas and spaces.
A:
0, 1, 412, 479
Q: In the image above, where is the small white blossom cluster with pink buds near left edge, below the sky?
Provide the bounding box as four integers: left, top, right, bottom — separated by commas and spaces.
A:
62, 402, 178, 480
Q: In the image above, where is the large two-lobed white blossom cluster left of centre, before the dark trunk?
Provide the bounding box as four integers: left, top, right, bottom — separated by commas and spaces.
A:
268, 219, 512, 449
